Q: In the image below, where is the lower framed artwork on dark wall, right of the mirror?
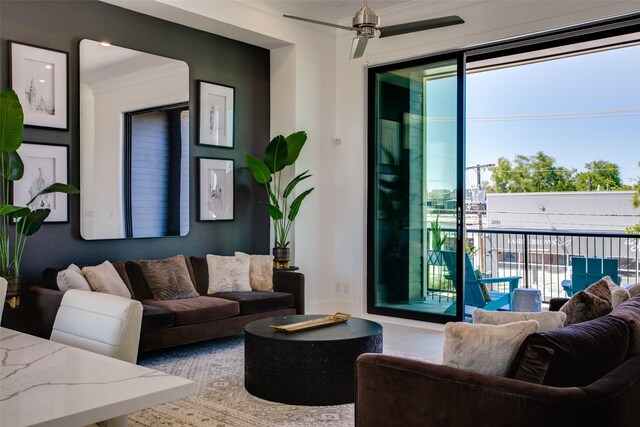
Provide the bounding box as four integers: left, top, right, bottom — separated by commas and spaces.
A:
198, 157, 234, 221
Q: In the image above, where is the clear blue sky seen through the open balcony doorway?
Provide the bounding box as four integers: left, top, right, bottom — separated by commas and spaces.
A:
466, 42, 640, 187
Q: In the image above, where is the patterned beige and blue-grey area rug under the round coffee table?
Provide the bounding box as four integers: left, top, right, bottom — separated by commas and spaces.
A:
129, 335, 354, 427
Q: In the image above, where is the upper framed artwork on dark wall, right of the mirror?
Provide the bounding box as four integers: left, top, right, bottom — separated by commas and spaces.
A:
198, 80, 234, 148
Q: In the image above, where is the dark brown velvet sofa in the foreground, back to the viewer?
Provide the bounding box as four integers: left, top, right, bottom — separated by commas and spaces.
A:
355, 295, 640, 427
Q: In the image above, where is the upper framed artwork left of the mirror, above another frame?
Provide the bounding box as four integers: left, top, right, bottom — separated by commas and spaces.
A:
9, 41, 69, 130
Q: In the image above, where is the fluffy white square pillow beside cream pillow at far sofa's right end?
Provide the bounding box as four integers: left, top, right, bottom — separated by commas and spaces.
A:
207, 252, 251, 294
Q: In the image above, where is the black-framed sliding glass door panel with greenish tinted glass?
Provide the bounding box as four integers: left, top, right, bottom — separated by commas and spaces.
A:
367, 53, 464, 322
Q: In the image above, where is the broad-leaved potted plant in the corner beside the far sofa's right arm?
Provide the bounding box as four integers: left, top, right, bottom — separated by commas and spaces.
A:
244, 131, 313, 268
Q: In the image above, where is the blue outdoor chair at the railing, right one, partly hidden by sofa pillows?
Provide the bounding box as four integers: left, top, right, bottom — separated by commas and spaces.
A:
560, 257, 618, 297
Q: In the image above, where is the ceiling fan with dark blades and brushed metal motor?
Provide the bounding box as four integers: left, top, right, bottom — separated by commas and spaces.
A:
283, 0, 464, 59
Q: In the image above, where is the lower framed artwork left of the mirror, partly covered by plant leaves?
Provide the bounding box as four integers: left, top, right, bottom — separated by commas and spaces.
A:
13, 142, 69, 222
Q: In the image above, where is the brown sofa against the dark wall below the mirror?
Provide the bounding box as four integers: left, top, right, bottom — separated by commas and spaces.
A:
28, 256, 304, 353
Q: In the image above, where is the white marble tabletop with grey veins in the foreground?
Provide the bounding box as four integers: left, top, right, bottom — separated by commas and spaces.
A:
0, 327, 196, 427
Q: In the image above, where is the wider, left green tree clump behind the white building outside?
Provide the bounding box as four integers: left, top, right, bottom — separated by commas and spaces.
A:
488, 151, 576, 193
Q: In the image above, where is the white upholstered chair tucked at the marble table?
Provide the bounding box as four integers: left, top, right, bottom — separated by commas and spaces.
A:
50, 289, 142, 427
